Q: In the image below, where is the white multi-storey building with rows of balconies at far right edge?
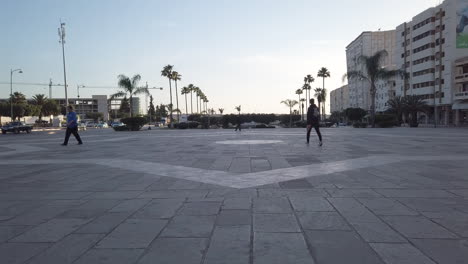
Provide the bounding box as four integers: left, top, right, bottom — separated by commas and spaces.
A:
395, 0, 468, 125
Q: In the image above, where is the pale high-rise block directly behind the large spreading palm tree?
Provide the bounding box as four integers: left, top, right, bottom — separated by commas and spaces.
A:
346, 30, 396, 112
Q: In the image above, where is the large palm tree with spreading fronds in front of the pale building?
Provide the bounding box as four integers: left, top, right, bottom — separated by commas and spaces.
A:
343, 50, 403, 127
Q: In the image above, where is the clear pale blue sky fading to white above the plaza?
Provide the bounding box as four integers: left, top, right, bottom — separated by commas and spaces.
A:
0, 0, 440, 113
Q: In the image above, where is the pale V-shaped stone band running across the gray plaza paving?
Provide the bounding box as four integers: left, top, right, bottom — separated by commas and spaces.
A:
0, 155, 468, 188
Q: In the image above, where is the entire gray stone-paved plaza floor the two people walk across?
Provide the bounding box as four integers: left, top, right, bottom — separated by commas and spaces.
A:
0, 128, 468, 264
